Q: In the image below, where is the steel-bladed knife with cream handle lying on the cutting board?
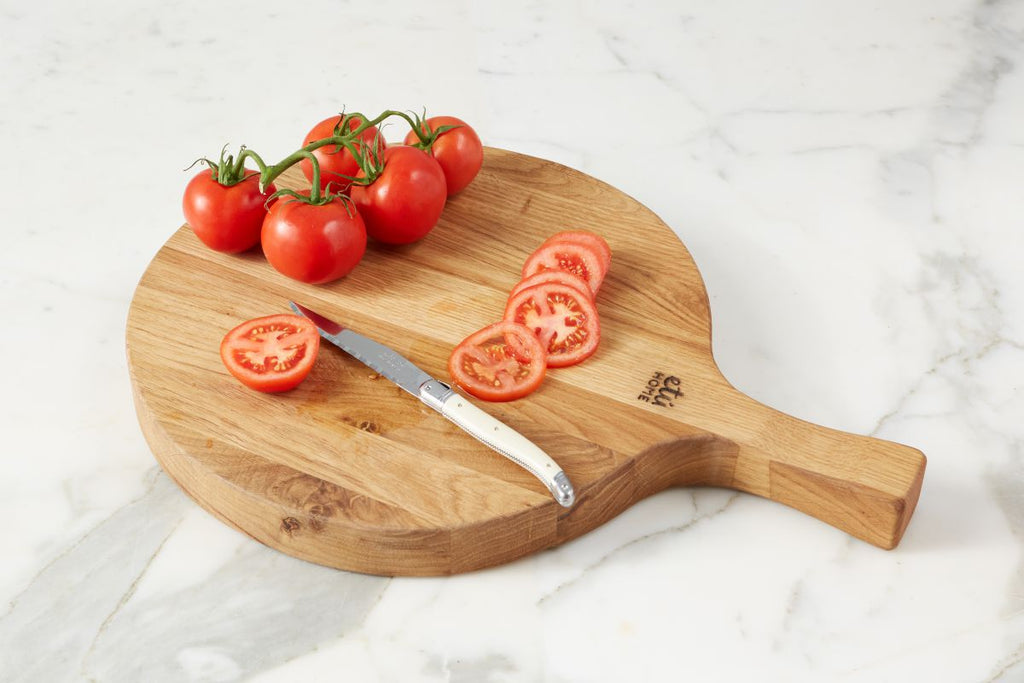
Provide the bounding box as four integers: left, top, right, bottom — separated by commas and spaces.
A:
288, 301, 575, 508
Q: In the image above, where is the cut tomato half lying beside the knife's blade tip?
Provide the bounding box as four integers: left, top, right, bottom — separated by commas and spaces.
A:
220, 313, 319, 392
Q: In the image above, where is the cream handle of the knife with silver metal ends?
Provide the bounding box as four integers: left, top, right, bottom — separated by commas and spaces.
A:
420, 380, 575, 508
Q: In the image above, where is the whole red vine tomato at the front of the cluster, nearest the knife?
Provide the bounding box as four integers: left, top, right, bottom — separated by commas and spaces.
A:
262, 197, 367, 285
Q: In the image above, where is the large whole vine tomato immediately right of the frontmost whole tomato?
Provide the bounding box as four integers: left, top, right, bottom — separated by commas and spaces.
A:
351, 144, 447, 245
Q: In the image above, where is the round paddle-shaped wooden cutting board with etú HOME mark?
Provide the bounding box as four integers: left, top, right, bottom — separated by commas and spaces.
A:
127, 148, 925, 575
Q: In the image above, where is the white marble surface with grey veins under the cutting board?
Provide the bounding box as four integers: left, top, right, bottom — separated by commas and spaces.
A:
0, 0, 1024, 683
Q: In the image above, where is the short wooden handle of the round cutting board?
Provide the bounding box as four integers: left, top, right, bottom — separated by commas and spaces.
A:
674, 386, 926, 549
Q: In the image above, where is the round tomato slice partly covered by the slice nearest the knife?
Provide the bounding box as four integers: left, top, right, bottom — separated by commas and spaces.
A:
504, 283, 601, 368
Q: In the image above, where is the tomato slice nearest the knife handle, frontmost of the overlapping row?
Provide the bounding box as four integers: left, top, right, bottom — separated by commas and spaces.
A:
449, 321, 547, 400
